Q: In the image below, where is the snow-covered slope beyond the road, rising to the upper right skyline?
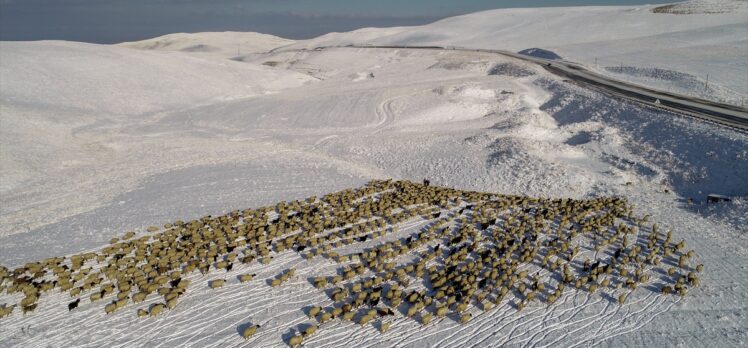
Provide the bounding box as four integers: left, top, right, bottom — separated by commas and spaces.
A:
289, 0, 748, 104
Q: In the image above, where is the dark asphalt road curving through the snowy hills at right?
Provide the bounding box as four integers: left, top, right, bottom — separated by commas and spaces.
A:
340, 45, 748, 131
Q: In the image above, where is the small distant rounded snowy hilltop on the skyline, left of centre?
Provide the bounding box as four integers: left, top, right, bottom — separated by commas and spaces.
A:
119, 31, 294, 58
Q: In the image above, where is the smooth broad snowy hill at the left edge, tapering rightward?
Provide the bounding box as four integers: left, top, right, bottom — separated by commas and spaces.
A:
0, 41, 310, 114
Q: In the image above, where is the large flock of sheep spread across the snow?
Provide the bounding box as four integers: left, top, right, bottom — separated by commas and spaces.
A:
0, 180, 703, 346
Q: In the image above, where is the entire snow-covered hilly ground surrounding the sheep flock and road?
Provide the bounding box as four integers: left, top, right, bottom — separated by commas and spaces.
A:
0, 1, 748, 347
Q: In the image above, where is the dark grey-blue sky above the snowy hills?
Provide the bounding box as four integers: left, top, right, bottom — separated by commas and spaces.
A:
0, 0, 668, 43
